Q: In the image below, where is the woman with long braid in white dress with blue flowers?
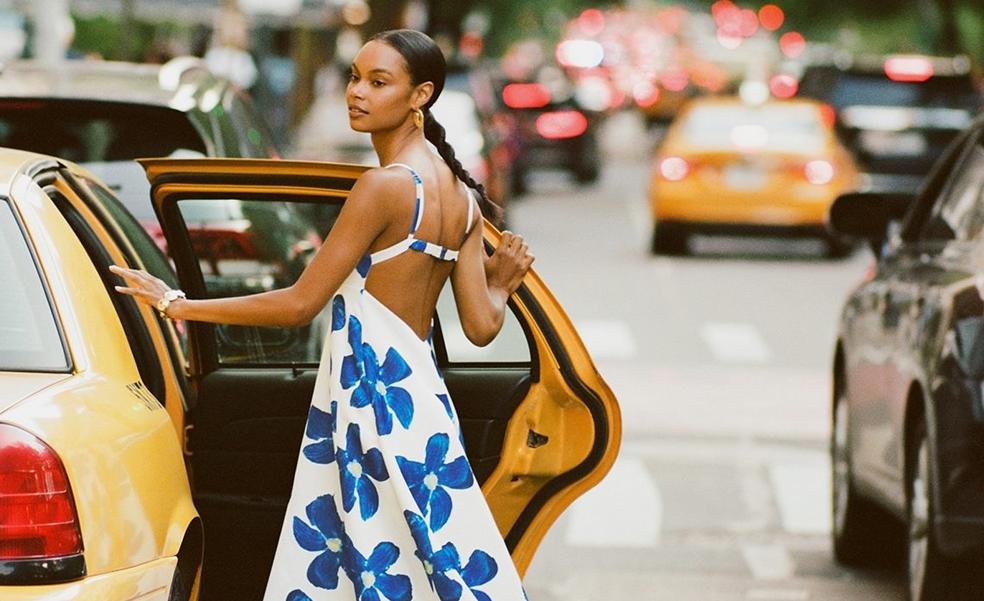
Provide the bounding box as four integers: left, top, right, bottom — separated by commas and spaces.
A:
111, 30, 533, 601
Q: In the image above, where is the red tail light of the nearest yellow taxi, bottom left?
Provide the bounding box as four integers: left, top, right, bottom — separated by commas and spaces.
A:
0, 424, 82, 561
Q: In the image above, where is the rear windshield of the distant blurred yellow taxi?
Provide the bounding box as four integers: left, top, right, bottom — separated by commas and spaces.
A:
682, 104, 827, 153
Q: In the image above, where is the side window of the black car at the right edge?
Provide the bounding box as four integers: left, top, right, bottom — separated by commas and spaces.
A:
923, 142, 984, 242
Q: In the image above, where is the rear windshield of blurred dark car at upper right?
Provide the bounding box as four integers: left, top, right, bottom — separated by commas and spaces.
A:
829, 73, 978, 110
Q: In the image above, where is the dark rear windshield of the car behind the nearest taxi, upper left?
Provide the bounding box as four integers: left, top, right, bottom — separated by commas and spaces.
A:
0, 98, 206, 163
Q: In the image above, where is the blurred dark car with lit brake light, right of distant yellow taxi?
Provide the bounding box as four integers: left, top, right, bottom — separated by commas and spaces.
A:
799, 55, 982, 192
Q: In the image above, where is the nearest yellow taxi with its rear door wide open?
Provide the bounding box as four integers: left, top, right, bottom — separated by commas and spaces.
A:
0, 149, 621, 601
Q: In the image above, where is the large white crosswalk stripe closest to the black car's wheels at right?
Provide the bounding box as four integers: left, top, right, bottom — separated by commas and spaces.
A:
769, 460, 831, 534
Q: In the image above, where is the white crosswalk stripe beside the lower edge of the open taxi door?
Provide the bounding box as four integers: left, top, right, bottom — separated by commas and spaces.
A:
564, 457, 663, 547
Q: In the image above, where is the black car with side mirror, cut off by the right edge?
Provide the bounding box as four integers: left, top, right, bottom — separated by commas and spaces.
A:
830, 113, 984, 601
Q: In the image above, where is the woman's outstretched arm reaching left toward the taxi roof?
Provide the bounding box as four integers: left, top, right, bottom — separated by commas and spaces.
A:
110, 169, 412, 327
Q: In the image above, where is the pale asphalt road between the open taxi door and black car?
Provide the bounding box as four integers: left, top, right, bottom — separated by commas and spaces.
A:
510, 116, 905, 601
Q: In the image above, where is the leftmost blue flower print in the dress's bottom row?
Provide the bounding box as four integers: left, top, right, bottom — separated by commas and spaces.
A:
288, 495, 349, 601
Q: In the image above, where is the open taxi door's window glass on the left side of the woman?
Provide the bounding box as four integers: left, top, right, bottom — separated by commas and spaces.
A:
171, 198, 340, 365
